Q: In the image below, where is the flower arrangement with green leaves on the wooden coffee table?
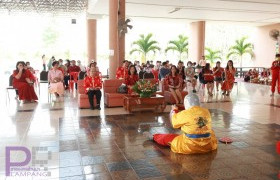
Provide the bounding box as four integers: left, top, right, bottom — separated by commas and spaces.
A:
132, 80, 157, 97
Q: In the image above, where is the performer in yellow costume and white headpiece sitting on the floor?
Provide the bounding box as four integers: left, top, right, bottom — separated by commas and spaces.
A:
145, 94, 217, 154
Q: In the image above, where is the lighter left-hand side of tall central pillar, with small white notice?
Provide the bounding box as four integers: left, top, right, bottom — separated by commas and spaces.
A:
109, 0, 119, 79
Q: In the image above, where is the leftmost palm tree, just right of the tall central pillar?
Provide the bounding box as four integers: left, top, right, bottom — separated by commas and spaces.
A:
129, 33, 160, 62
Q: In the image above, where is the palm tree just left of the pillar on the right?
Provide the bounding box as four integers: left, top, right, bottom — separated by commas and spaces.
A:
165, 35, 189, 60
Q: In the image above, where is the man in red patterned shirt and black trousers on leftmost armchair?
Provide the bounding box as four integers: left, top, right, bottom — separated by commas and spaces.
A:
84, 68, 102, 110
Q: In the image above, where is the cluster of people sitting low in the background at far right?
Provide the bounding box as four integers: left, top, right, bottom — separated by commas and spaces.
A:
244, 68, 271, 84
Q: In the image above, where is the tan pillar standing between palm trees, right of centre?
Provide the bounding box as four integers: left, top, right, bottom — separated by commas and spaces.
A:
189, 21, 205, 63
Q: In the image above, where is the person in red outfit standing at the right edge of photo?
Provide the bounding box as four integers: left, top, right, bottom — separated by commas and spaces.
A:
271, 54, 280, 96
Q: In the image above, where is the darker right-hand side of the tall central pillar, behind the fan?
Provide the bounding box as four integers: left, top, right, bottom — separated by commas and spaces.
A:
118, 0, 125, 66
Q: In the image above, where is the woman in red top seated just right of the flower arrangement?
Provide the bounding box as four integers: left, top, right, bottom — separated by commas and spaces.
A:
165, 65, 183, 104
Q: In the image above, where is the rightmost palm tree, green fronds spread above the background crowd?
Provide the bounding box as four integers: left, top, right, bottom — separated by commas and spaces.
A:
227, 37, 254, 67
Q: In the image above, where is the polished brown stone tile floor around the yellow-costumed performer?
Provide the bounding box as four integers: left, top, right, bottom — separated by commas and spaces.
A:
0, 83, 280, 180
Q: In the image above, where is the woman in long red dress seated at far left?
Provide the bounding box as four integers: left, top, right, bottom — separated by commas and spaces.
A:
13, 61, 38, 103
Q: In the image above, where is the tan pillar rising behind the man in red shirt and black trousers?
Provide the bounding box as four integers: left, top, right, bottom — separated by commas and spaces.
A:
87, 19, 96, 64
